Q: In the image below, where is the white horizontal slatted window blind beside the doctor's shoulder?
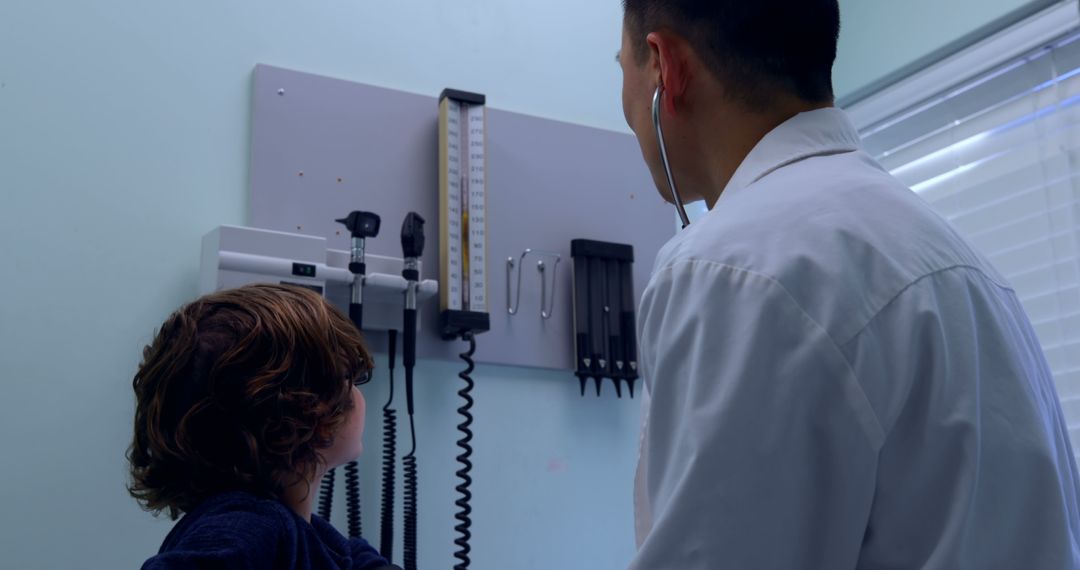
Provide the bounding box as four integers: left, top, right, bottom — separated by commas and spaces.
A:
862, 32, 1080, 451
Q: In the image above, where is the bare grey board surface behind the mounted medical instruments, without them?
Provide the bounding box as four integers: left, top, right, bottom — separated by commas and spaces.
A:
249, 66, 675, 369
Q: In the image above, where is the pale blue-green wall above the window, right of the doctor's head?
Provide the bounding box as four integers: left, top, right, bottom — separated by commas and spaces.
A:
834, 0, 1054, 98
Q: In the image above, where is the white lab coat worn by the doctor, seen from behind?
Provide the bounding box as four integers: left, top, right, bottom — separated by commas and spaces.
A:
632, 109, 1080, 570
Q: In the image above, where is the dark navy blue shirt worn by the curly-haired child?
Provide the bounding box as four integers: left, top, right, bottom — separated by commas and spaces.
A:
143, 491, 395, 570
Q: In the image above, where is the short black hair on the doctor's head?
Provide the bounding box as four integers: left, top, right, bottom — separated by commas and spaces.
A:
623, 0, 840, 108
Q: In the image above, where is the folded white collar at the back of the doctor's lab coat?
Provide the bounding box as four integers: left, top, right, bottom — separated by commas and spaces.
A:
719, 107, 862, 201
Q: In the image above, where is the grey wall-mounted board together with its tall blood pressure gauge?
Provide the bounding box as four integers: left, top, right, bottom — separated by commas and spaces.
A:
248, 66, 675, 369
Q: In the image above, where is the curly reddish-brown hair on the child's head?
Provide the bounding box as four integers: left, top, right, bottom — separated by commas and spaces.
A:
127, 285, 372, 519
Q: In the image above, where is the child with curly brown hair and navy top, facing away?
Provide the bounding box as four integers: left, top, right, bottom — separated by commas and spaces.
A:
129, 285, 395, 570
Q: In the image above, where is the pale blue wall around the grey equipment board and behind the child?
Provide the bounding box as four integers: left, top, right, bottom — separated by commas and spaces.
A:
0, 0, 637, 570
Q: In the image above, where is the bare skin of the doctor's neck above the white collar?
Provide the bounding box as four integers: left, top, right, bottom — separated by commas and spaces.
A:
678, 82, 833, 209
